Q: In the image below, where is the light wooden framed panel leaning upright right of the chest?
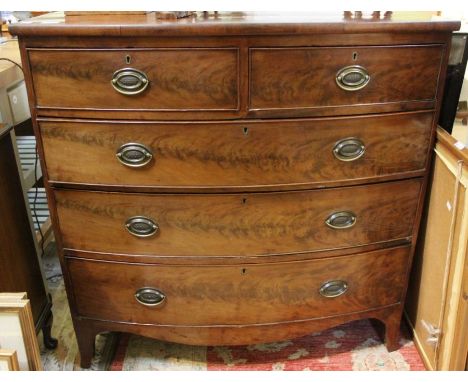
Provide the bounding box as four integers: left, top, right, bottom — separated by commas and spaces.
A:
406, 132, 468, 370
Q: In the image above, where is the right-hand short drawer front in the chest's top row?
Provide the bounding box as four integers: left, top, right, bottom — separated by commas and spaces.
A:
250, 45, 443, 115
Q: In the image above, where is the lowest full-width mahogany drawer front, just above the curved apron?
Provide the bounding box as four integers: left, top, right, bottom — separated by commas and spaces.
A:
67, 247, 408, 325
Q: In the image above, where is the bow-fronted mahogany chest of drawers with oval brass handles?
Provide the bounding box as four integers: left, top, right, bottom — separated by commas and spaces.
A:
12, 14, 459, 367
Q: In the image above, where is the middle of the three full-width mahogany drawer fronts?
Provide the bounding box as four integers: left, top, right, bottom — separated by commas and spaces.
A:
54, 179, 421, 257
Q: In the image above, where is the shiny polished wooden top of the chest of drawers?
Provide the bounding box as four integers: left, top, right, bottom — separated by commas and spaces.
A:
10, 11, 460, 36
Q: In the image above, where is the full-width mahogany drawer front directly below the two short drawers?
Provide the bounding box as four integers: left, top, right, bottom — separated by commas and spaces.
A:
40, 112, 433, 189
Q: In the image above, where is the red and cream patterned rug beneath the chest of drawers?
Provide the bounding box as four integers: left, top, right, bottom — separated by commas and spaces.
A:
110, 320, 425, 371
